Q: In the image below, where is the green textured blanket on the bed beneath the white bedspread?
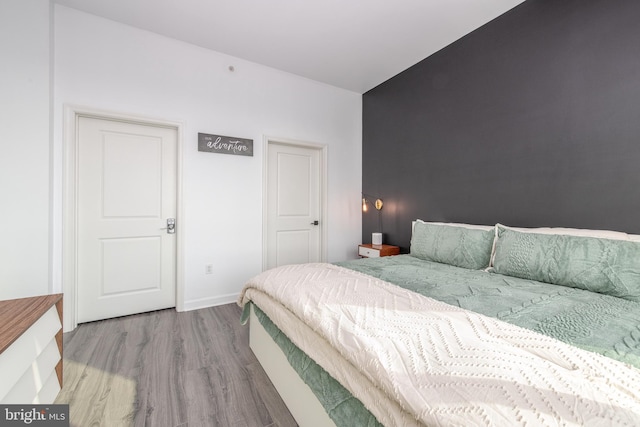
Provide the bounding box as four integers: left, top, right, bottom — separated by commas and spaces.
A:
247, 255, 640, 426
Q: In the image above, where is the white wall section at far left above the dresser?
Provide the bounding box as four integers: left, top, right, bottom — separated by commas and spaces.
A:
0, 0, 51, 299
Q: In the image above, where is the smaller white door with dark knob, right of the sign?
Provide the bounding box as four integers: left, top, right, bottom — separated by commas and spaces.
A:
267, 142, 323, 268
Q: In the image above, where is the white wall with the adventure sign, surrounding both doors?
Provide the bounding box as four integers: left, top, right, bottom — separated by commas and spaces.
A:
54, 6, 362, 308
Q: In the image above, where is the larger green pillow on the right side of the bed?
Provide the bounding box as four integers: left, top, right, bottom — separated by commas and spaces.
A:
493, 225, 640, 301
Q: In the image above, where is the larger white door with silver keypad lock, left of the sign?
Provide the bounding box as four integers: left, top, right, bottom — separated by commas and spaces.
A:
77, 117, 181, 322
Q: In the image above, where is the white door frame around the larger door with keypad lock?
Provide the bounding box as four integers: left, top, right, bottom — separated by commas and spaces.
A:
62, 105, 185, 332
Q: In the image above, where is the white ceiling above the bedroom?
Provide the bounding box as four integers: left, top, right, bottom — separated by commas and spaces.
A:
54, 0, 524, 93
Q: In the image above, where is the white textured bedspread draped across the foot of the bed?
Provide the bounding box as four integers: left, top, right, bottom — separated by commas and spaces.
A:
239, 264, 640, 426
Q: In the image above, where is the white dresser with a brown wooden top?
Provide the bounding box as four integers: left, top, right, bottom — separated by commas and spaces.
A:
0, 294, 62, 404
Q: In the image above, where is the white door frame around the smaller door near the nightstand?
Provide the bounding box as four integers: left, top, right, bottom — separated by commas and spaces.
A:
262, 135, 329, 271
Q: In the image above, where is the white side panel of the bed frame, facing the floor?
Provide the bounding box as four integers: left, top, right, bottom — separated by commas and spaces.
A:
249, 304, 336, 427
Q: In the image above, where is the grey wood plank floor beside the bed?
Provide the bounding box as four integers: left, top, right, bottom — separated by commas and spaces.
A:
56, 304, 296, 427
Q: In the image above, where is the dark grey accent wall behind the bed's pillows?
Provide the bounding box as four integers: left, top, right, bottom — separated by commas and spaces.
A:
362, 0, 640, 251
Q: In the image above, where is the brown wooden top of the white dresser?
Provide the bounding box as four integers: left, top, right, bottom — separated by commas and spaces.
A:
0, 294, 62, 353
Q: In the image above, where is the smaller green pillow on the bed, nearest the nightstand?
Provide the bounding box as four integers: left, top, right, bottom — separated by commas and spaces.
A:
410, 221, 494, 270
